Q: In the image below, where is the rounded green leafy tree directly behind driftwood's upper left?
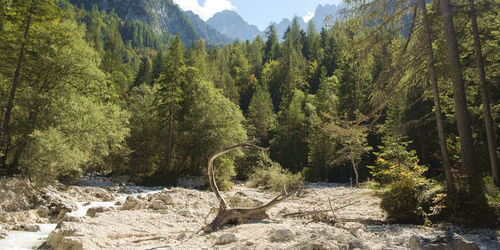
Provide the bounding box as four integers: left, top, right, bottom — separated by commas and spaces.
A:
176, 81, 247, 174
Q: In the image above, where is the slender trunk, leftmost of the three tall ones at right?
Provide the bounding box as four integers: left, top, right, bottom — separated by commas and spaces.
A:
420, 0, 455, 193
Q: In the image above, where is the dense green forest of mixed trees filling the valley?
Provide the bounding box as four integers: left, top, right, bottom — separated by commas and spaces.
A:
0, 0, 500, 225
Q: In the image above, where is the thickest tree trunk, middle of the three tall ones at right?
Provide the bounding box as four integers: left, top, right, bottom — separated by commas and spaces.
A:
440, 0, 482, 195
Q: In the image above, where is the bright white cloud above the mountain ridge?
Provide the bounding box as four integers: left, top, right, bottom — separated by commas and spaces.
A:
174, 0, 236, 21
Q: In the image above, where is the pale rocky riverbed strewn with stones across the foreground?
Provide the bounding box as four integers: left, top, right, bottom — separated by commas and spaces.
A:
0, 177, 500, 249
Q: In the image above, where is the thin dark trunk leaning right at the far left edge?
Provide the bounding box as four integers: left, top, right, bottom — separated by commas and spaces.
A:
0, 6, 35, 169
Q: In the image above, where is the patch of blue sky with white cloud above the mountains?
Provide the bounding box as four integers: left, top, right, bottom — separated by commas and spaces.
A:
174, 0, 342, 30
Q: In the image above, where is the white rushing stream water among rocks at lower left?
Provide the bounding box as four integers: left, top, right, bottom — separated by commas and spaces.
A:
0, 181, 161, 250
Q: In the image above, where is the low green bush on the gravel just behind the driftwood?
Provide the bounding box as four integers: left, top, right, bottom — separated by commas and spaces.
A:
247, 163, 303, 191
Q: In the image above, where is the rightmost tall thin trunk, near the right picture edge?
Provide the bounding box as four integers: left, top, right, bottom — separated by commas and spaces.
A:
469, 0, 500, 187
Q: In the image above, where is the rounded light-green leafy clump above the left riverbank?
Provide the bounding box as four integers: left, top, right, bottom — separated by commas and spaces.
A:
19, 94, 129, 184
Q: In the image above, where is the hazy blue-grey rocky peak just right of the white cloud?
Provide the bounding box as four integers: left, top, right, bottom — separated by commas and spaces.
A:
207, 10, 263, 41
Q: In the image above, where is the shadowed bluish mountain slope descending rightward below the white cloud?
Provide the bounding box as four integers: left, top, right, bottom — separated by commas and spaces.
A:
70, 0, 231, 44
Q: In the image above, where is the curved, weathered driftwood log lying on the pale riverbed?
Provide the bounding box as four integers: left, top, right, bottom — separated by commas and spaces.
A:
203, 143, 293, 233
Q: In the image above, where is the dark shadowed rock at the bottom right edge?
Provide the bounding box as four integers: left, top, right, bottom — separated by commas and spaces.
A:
410, 235, 479, 250
